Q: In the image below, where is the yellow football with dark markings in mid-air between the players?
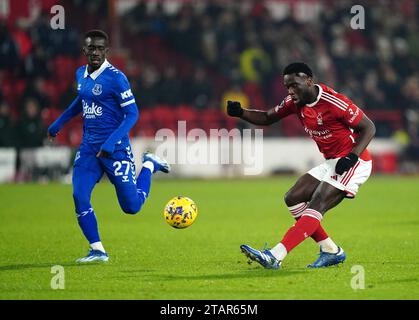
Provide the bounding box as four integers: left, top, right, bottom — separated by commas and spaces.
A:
163, 196, 198, 229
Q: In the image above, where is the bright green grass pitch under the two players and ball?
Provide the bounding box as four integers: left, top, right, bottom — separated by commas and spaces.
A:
0, 176, 419, 300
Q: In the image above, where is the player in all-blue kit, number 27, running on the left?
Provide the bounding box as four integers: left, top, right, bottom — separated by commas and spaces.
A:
48, 30, 170, 263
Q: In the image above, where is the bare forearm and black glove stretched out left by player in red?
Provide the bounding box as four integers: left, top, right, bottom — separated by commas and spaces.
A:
227, 101, 279, 126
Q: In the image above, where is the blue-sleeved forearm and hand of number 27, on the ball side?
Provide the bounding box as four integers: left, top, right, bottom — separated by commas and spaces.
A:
96, 103, 138, 157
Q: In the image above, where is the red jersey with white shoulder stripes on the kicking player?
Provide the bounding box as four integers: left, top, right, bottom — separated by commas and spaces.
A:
274, 84, 371, 160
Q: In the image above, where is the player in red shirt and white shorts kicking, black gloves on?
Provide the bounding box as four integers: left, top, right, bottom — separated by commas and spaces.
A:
227, 62, 375, 269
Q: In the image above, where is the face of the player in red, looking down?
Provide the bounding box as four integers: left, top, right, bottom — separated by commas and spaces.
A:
284, 73, 312, 107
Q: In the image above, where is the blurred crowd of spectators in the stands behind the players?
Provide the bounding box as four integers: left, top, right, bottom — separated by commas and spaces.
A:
0, 0, 419, 170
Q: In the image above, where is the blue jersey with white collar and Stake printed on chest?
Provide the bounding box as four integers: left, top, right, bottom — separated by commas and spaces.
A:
76, 60, 135, 144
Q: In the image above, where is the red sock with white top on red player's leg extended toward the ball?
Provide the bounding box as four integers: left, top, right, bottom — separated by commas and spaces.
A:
281, 209, 324, 252
